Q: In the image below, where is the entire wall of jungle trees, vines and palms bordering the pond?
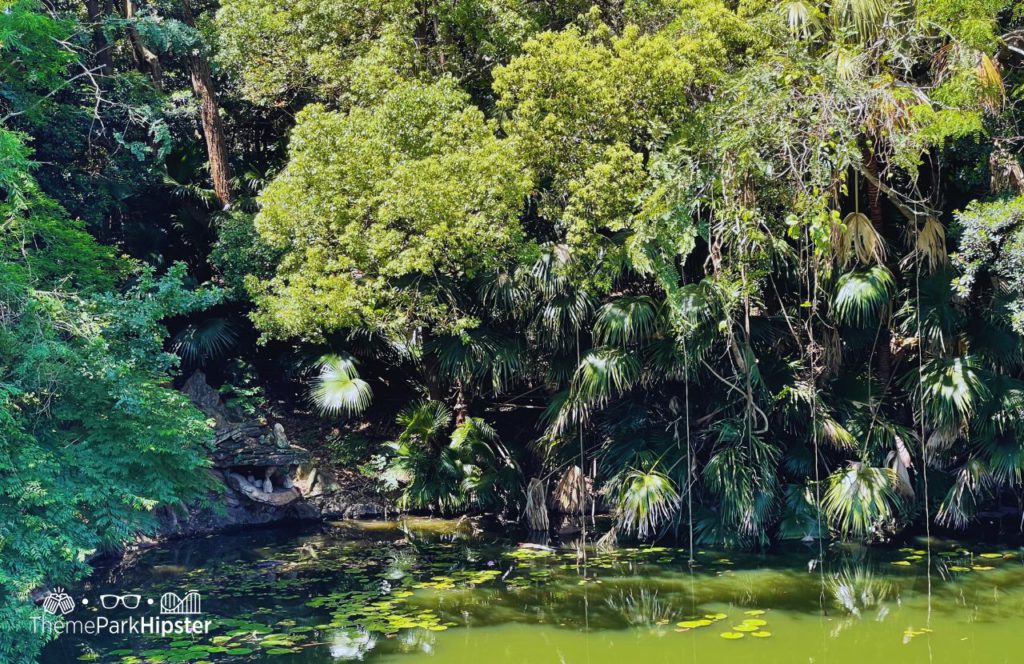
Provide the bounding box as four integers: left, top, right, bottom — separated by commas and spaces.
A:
0, 0, 1024, 662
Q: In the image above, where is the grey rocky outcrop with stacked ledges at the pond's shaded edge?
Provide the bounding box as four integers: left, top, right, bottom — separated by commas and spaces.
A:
159, 371, 388, 537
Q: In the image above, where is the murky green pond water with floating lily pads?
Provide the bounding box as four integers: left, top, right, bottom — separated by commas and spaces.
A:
42, 520, 1024, 664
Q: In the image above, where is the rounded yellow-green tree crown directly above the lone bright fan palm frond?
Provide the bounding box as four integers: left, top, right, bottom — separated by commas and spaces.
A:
254, 79, 531, 337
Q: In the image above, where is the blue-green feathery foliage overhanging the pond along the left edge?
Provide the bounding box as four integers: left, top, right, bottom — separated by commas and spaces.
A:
0, 2, 220, 663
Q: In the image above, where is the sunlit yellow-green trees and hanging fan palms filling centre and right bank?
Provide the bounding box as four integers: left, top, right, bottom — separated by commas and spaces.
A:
232, 0, 1024, 545
